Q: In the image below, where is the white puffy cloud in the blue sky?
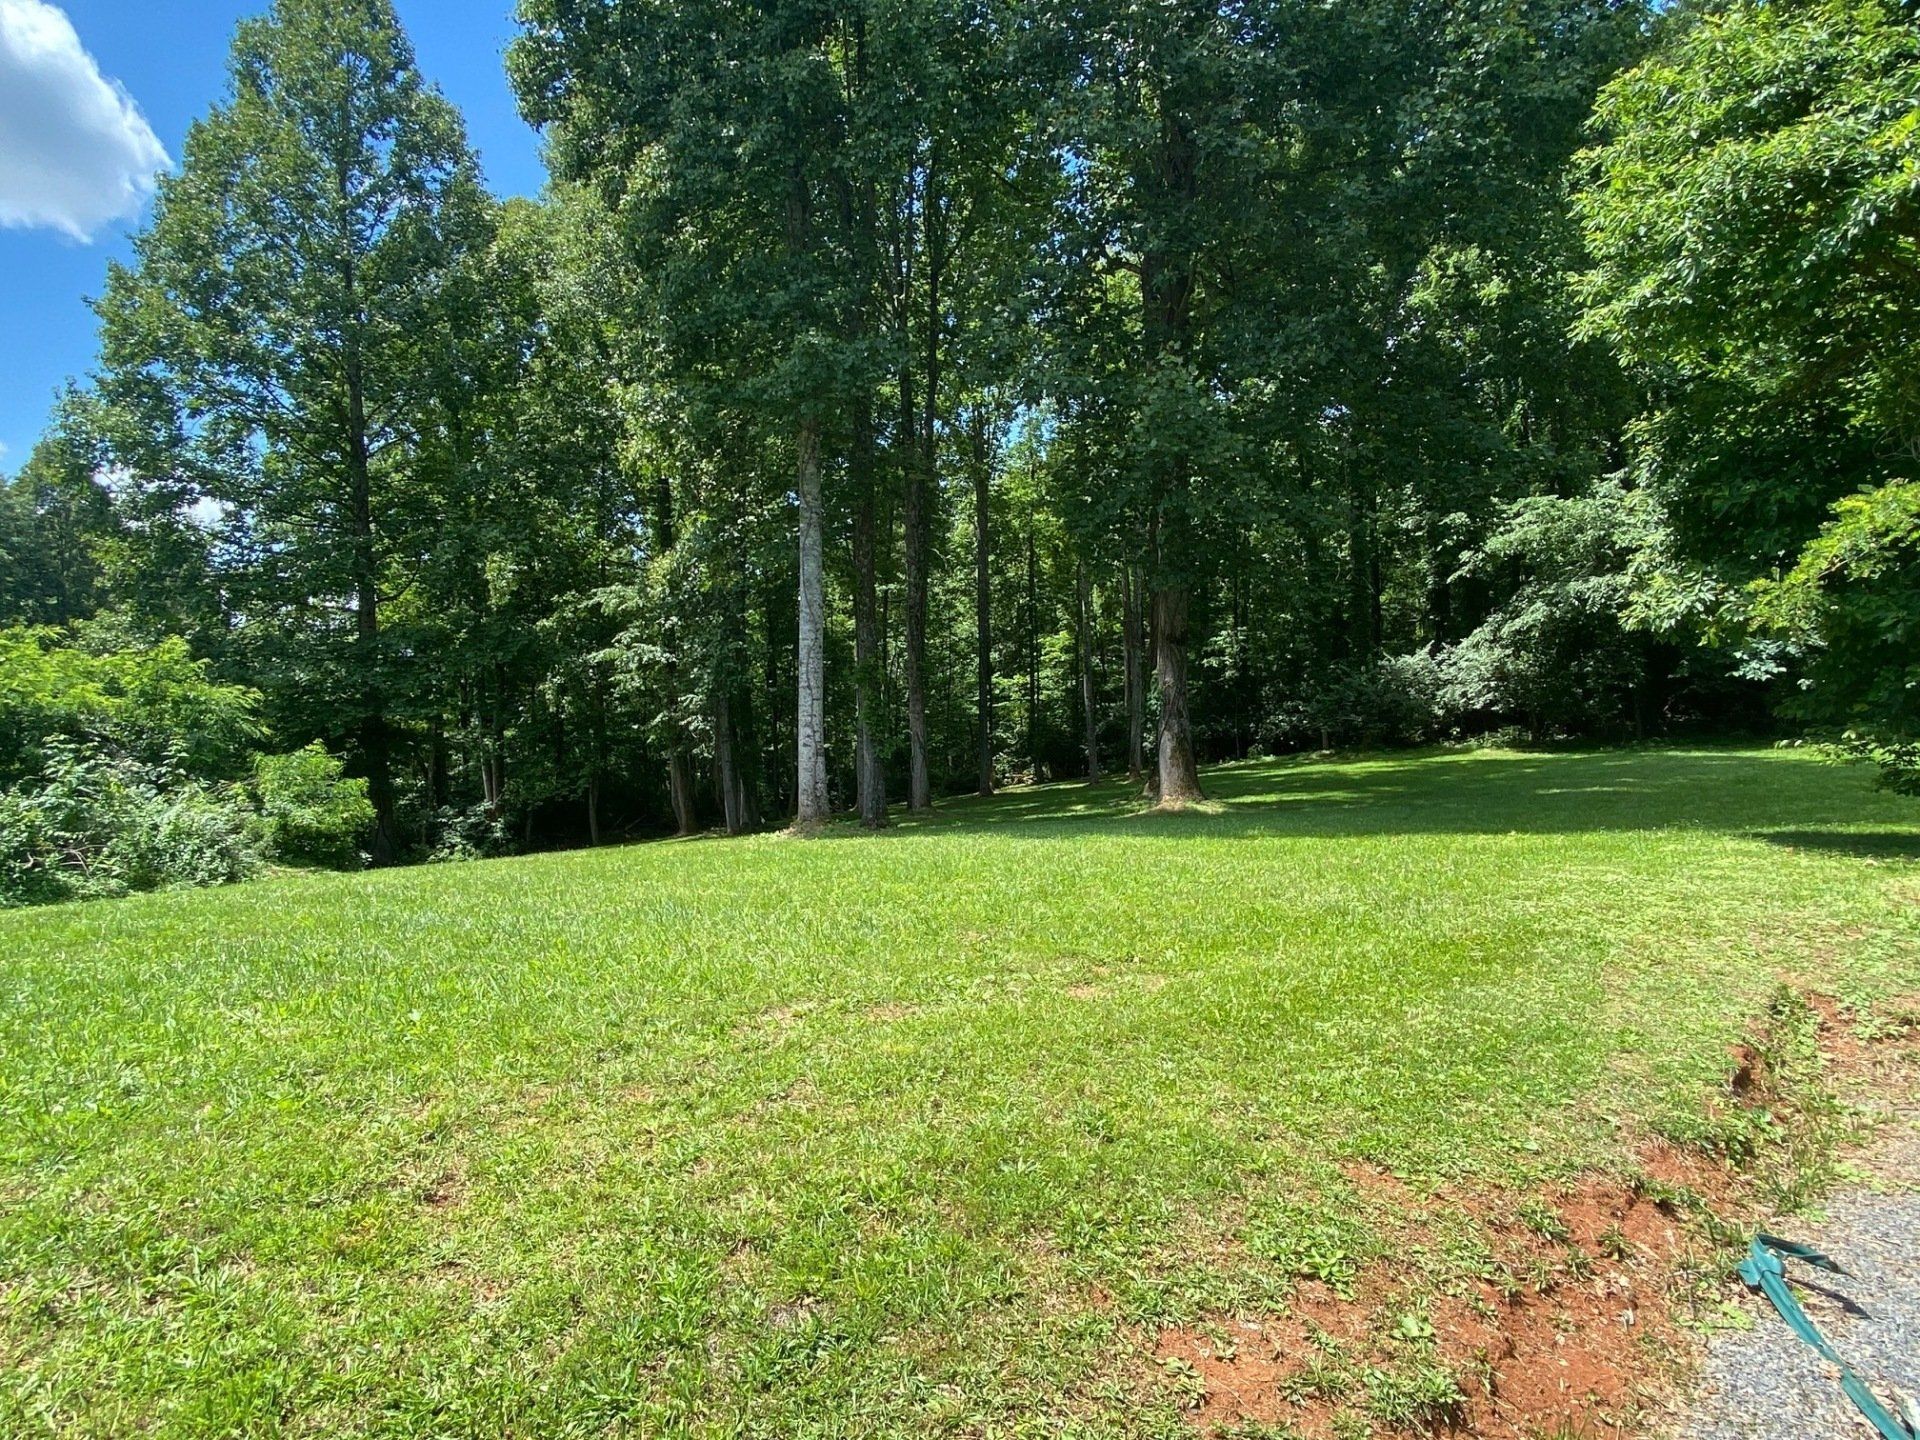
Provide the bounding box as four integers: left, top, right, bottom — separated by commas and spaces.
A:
0, 0, 167, 240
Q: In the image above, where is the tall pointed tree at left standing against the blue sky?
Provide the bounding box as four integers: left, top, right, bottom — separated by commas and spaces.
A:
100, 0, 492, 860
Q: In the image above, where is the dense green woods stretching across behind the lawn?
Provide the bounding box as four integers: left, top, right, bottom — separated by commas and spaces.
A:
0, 0, 1920, 899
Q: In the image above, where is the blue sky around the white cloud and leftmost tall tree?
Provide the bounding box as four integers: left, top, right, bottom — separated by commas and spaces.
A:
0, 0, 545, 474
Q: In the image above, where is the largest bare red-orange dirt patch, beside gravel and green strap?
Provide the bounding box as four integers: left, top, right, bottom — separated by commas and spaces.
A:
1156, 1156, 1712, 1440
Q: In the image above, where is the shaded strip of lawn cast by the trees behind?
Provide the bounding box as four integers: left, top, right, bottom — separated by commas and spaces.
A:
837, 749, 1920, 858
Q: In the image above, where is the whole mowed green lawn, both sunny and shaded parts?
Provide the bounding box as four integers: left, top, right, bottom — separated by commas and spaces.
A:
0, 751, 1920, 1436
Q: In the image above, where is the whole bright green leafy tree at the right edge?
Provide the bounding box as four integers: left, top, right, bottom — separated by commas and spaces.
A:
1576, 0, 1920, 783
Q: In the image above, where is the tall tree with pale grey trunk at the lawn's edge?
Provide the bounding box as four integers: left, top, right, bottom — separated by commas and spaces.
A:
509, 0, 856, 826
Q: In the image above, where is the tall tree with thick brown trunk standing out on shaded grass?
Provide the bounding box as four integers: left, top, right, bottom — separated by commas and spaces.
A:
1050, 0, 1290, 804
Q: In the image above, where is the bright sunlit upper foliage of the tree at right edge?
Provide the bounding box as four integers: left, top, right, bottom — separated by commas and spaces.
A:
1578, 0, 1920, 451
